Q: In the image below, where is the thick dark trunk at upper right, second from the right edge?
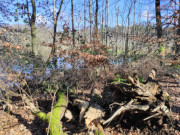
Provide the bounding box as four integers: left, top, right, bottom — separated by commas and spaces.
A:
155, 0, 162, 38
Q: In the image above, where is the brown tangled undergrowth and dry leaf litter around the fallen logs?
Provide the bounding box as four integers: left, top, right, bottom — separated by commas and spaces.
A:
0, 37, 180, 135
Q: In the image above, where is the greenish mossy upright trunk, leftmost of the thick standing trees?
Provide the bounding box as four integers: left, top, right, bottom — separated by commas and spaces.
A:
30, 0, 38, 56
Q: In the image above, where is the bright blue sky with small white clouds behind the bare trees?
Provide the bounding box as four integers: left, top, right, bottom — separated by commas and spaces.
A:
0, 0, 179, 29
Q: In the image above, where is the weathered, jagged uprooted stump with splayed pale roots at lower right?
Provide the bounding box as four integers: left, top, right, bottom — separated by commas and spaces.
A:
103, 69, 171, 125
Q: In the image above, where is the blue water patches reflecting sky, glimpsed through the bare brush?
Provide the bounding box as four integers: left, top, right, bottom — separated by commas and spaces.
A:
0, 56, 126, 89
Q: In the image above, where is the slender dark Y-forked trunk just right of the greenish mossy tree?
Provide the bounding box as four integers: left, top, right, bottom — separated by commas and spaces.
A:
51, 0, 63, 54
